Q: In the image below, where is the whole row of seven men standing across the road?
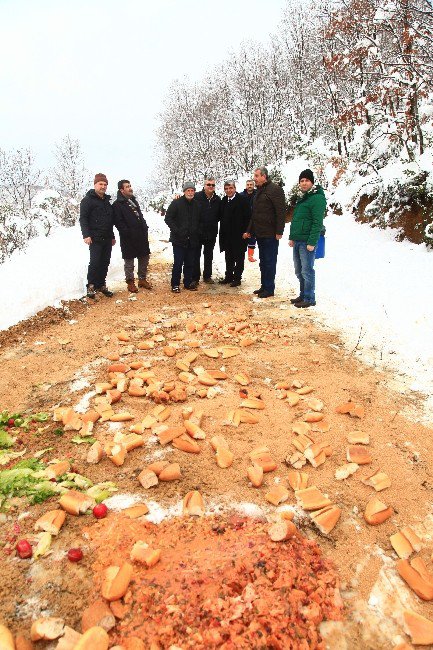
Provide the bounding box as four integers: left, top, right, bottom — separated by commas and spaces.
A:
80, 167, 326, 307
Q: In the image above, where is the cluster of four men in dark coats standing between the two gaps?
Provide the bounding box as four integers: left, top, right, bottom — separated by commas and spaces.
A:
165, 167, 286, 298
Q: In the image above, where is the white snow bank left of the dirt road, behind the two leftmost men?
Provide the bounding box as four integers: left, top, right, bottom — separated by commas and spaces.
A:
0, 213, 168, 329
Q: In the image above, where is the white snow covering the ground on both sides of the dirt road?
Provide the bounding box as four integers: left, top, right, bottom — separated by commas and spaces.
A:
0, 205, 433, 420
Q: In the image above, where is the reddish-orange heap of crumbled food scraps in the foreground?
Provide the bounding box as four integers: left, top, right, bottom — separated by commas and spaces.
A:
86, 515, 343, 650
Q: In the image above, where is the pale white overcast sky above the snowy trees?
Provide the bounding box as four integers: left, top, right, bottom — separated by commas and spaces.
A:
0, 0, 285, 192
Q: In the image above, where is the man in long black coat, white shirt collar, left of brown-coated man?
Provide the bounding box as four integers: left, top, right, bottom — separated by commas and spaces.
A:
220, 181, 251, 287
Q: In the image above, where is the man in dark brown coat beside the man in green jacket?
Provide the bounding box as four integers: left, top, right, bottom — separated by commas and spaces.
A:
244, 167, 286, 298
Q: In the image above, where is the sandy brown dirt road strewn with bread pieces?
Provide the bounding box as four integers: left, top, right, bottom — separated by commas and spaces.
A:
0, 265, 433, 650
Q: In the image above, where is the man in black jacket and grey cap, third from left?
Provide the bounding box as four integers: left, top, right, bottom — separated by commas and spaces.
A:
164, 182, 200, 293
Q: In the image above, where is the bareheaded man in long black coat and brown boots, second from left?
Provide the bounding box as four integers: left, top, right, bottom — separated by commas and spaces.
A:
113, 179, 152, 293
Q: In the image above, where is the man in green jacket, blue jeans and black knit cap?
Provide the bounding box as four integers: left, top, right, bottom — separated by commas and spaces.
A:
289, 169, 326, 308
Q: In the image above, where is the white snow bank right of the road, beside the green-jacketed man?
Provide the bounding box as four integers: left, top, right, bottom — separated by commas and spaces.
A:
277, 159, 433, 412
